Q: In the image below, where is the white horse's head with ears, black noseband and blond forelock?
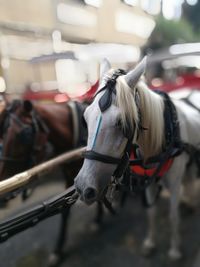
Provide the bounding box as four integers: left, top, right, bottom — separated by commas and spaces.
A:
75, 59, 146, 204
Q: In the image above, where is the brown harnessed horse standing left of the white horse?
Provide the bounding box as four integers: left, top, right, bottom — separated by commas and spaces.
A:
0, 100, 102, 264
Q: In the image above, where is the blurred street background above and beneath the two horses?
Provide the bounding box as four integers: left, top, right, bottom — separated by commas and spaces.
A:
0, 0, 200, 267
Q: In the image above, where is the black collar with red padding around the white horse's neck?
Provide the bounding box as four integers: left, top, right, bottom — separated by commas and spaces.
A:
130, 91, 184, 190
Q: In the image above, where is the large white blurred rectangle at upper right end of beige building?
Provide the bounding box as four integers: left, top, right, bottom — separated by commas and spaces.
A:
115, 10, 155, 39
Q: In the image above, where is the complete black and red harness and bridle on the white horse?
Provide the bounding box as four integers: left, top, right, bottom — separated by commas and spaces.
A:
83, 70, 184, 206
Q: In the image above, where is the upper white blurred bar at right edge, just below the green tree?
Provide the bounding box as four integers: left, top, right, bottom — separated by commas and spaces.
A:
169, 43, 200, 55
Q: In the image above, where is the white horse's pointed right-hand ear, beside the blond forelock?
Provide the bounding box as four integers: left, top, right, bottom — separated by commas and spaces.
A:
124, 56, 147, 88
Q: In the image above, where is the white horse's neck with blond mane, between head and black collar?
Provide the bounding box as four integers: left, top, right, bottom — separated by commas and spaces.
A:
138, 83, 165, 160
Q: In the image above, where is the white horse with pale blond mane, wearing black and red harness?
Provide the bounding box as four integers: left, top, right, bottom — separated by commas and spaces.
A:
75, 59, 200, 259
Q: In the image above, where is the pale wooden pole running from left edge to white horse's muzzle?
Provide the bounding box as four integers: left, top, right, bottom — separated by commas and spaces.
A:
0, 147, 86, 195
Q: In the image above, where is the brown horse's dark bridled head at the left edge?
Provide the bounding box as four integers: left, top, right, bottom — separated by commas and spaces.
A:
0, 100, 47, 180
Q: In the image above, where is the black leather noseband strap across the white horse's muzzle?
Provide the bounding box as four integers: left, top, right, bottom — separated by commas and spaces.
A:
83, 150, 121, 165
